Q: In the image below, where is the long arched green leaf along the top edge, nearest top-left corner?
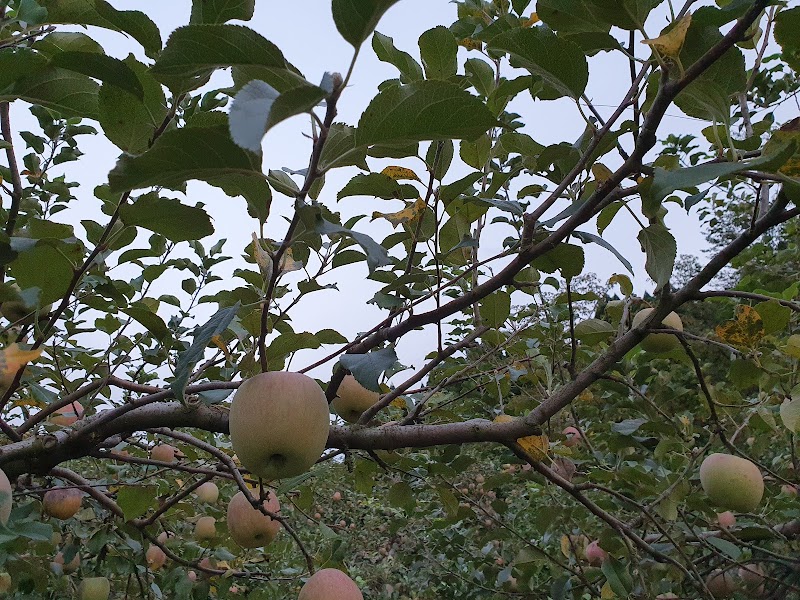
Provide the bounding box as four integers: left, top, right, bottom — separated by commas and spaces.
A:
40, 0, 161, 58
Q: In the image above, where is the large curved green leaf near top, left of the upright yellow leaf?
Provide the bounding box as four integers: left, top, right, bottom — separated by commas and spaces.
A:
489, 27, 589, 99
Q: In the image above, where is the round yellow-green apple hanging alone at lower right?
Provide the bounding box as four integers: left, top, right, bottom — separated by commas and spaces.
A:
700, 453, 764, 512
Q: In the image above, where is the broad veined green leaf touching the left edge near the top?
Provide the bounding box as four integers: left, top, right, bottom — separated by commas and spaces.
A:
0, 66, 100, 120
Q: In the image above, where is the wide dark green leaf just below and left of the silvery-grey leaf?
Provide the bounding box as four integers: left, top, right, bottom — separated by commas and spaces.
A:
108, 127, 261, 192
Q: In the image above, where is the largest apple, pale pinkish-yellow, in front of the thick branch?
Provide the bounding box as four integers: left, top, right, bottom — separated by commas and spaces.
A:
228, 371, 330, 481
